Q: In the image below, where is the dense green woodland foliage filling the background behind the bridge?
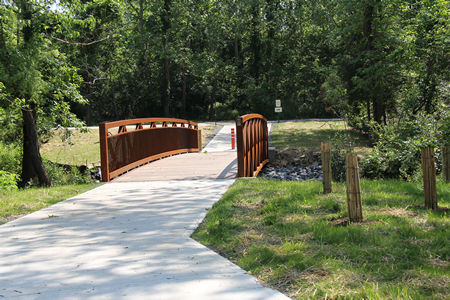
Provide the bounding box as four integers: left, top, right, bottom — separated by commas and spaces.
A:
0, 0, 450, 186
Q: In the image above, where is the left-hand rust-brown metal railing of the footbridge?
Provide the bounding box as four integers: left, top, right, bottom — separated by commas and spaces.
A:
99, 118, 201, 182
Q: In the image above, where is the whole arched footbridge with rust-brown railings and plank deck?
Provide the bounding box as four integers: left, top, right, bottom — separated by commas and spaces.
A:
100, 114, 268, 182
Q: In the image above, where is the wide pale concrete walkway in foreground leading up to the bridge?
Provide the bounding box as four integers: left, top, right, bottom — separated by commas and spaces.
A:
0, 123, 288, 300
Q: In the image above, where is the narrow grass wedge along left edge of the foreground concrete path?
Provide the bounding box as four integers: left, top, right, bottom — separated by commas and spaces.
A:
0, 183, 100, 224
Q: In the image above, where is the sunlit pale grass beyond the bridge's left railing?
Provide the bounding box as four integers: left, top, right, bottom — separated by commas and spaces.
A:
41, 126, 216, 168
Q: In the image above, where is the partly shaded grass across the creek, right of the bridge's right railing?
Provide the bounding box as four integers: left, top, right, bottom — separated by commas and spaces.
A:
271, 121, 369, 152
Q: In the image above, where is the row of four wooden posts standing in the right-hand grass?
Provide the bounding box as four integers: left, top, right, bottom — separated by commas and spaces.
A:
321, 142, 450, 222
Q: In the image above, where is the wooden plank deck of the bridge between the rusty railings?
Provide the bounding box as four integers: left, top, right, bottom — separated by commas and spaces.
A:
112, 151, 237, 182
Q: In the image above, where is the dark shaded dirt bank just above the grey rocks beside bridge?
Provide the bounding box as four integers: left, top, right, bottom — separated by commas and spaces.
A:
269, 149, 320, 168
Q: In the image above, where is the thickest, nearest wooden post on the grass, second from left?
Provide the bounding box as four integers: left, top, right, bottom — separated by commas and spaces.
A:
345, 153, 363, 222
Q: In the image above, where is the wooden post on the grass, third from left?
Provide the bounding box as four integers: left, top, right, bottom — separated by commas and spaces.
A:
421, 147, 437, 209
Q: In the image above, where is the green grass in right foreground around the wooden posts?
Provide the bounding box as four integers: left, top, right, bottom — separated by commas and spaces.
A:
193, 178, 450, 299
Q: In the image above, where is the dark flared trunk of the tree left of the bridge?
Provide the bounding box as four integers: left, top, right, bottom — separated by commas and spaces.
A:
20, 109, 51, 188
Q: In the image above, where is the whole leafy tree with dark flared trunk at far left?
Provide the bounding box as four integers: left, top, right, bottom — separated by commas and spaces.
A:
0, 1, 85, 187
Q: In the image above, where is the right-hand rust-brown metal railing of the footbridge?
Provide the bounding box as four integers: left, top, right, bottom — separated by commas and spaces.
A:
236, 114, 269, 177
